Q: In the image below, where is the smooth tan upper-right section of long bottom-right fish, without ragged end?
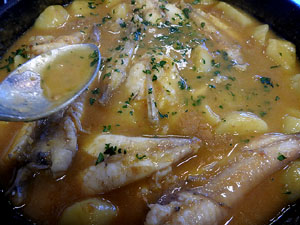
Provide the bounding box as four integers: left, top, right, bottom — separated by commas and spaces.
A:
199, 133, 300, 207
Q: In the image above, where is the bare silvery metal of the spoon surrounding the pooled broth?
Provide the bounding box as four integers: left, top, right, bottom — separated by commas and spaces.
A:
0, 44, 101, 121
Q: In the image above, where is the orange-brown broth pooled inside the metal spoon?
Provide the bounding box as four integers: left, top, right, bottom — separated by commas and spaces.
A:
41, 48, 97, 101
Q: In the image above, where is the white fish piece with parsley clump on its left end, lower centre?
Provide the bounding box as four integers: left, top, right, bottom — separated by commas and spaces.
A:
80, 134, 200, 194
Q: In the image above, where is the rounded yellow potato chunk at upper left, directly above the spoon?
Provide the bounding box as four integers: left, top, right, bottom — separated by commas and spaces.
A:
34, 5, 69, 29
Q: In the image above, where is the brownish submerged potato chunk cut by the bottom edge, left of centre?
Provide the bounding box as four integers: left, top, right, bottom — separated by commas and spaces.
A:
59, 198, 118, 225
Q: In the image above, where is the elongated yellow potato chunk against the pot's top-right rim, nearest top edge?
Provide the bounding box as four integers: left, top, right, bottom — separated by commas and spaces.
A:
216, 2, 252, 27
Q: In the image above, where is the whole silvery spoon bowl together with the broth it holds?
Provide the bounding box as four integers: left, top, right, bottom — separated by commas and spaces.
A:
0, 44, 101, 121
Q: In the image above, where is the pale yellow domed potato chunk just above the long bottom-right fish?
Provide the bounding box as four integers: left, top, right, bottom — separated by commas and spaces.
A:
216, 112, 268, 135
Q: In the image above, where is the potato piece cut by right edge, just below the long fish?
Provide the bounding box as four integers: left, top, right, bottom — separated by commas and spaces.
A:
283, 160, 300, 201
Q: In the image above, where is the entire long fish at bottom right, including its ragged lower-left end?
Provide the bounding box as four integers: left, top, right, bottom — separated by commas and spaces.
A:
145, 133, 300, 225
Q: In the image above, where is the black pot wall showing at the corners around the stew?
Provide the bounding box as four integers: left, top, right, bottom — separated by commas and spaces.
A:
0, 0, 300, 225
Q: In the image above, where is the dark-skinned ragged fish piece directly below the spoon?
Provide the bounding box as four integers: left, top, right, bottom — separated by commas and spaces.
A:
7, 93, 85, 205
